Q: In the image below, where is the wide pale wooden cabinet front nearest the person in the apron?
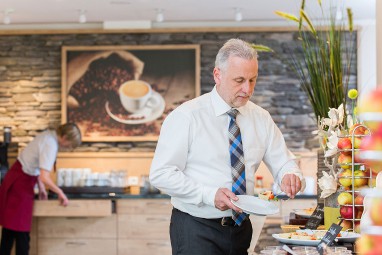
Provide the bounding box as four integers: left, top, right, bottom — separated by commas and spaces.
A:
37, 215, 117, 255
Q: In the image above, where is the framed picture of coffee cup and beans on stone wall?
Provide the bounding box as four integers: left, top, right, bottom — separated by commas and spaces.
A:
61, 45, 200, 142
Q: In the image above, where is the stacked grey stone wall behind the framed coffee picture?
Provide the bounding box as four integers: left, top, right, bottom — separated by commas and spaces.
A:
0, 32, 357, 151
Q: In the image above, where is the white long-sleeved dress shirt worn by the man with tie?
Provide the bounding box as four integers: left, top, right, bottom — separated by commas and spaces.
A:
150, 87, 302, 218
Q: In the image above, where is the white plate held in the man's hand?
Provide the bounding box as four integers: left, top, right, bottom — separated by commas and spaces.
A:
232, 195, 280, 216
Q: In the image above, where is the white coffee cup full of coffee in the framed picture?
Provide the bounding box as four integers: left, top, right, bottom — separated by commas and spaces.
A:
119, 80, 153, 113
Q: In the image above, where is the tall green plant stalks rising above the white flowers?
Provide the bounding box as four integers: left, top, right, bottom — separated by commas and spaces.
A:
276, 0, 353, 128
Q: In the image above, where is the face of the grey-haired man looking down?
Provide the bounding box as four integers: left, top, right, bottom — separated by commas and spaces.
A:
213, 56, 258, 108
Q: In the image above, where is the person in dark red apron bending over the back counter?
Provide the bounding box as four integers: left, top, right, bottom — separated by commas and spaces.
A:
0, 123, 81, 255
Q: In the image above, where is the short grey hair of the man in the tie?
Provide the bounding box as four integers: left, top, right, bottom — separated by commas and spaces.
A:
215, 39, 257, 70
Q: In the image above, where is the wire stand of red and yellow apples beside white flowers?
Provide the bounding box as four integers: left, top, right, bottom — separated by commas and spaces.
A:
337, 124, 372, 233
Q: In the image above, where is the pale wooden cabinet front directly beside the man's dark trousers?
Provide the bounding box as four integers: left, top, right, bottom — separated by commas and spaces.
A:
117, 199, 172, 255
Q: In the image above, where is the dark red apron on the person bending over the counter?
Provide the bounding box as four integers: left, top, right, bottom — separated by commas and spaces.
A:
0, 161, 37, 232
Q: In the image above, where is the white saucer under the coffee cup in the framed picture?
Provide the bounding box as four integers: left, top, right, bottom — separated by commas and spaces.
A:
105, 91, 166, 125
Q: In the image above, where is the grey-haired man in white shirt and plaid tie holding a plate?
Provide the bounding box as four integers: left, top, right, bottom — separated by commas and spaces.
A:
150, 39, 304, 255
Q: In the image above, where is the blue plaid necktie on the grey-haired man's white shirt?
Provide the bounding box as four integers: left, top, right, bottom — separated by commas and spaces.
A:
227, 109, 247, 226
